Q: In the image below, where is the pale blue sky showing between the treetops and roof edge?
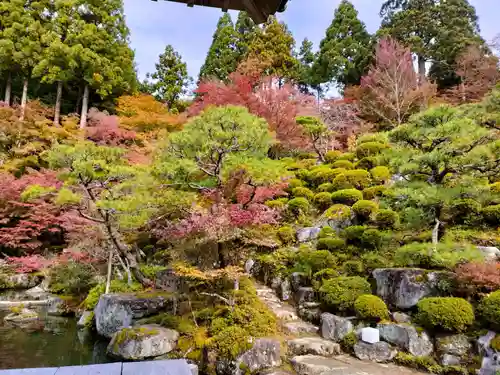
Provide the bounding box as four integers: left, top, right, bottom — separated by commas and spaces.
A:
125, 0, 500, 82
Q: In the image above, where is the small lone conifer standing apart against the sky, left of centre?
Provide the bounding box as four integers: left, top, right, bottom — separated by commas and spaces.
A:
151, 45, 190, 108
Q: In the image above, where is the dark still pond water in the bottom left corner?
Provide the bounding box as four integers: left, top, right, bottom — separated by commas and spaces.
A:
0, 311, 112, 369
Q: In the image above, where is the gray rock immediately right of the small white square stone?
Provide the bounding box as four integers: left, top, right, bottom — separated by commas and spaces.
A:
377, 323, 434, 357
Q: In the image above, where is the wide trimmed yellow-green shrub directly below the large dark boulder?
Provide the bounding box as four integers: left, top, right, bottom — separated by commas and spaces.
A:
416, 297, 474, 332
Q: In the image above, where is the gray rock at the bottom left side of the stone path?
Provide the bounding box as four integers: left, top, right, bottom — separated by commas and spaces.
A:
235, 339, 281, 375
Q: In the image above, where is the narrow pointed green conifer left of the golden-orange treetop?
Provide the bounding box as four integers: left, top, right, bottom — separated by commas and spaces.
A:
199, 13, 238, 81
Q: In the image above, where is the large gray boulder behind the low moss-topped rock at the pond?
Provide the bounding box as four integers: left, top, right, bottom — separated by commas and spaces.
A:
94, 294, 174, 338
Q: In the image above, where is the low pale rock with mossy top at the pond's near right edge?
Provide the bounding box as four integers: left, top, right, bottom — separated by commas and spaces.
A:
107, 324, 179, 360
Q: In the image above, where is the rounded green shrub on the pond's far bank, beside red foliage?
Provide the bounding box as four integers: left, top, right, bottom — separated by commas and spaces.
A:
49, 262, 96, 296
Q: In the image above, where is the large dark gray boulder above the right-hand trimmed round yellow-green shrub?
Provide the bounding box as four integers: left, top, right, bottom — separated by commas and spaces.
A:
373, 268, 449, 309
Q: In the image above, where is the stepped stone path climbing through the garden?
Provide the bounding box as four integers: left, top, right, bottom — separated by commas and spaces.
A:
256, 284, 424, 375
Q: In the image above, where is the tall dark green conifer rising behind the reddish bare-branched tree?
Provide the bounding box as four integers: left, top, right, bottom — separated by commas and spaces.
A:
313, 0, 372, 89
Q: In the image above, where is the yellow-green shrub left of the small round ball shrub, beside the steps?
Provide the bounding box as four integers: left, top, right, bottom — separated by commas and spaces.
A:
319, 276, 371, 312
